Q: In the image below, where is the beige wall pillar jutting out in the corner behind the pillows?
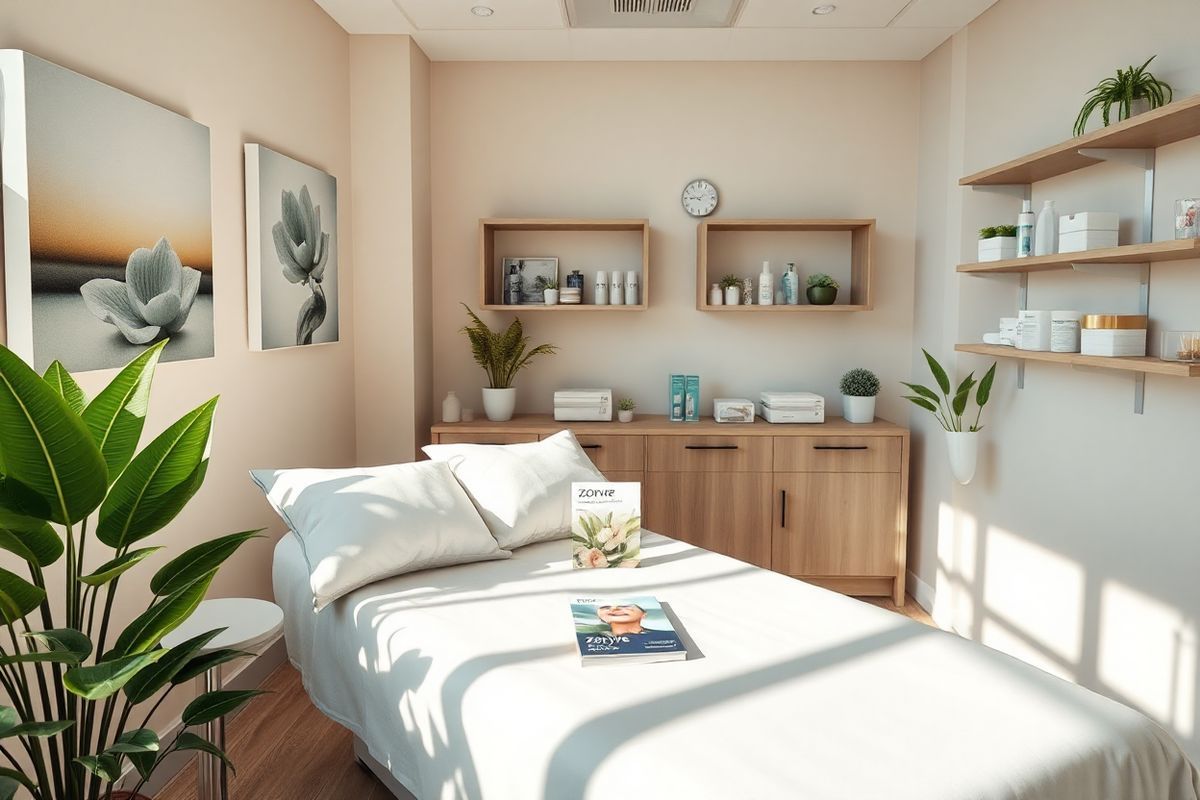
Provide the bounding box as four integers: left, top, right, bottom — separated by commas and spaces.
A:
349, 36, 432, 464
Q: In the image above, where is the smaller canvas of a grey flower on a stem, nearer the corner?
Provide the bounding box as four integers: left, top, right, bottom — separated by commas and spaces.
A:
246, 144, 338, 350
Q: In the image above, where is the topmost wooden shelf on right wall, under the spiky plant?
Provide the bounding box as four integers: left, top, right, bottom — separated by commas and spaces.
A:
959, 95, 1200, 186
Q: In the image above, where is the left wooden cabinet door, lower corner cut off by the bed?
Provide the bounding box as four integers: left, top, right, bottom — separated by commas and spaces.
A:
642, 473, 772, 567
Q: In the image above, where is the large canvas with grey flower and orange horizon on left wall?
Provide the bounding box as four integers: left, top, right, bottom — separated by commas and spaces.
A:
0, 50, 214, 372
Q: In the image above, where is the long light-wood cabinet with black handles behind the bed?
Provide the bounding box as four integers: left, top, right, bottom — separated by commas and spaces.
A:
433, 415, 908, 603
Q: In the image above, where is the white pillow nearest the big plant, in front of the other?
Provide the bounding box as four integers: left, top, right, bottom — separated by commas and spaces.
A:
250, 462, 511, 610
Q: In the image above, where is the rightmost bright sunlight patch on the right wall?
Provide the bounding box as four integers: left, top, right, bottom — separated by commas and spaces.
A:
1097, 581, 1196, 738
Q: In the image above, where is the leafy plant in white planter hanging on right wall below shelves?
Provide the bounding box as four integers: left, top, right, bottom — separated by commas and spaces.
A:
904, 349, 996, 485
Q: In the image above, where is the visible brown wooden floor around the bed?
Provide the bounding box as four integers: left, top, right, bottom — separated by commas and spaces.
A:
157, 597, 934, 800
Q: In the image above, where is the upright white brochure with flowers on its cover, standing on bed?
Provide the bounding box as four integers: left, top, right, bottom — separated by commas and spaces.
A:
571, 482, 642, 569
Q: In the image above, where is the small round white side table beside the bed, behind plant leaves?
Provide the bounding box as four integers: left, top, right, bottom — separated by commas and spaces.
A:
162, 597, 283, 800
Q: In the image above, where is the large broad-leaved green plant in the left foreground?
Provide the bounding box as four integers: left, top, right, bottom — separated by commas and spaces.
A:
0, 342, 259, 800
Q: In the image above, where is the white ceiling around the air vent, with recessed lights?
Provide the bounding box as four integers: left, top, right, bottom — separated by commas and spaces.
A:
317, 0, 996, 61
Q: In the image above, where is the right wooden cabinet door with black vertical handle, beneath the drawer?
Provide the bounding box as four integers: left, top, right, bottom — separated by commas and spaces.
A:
772, 473, 900, 577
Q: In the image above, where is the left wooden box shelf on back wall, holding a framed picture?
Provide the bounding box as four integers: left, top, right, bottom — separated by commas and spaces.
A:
479, 218, 650, 313
